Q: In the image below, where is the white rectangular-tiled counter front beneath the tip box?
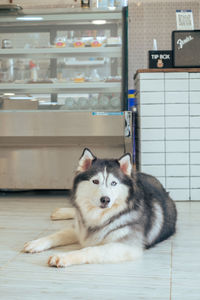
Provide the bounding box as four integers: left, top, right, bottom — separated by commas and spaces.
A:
136, 72, 200, 200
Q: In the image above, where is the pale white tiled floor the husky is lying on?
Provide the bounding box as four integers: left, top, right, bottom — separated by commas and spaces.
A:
0, 193, 200, 300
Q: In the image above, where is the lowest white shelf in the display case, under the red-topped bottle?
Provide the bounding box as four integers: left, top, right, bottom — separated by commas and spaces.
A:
0, 82, 121, 94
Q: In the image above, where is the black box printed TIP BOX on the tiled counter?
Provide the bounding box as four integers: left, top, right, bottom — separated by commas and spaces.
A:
149, 50, 173, 69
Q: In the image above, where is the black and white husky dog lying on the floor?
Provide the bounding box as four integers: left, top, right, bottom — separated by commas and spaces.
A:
24, 149, 177, 267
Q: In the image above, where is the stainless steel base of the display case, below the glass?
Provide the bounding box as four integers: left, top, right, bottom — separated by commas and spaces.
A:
0, 111, 125, 189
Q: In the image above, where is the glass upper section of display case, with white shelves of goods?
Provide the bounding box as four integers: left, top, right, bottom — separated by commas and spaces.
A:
0, 9, 127, 111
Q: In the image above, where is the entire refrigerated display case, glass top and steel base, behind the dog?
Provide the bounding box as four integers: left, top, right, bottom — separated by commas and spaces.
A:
0, 8, 132, 189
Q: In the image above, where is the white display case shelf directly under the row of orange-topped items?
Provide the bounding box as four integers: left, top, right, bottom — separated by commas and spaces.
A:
0, 46, 122, 58
